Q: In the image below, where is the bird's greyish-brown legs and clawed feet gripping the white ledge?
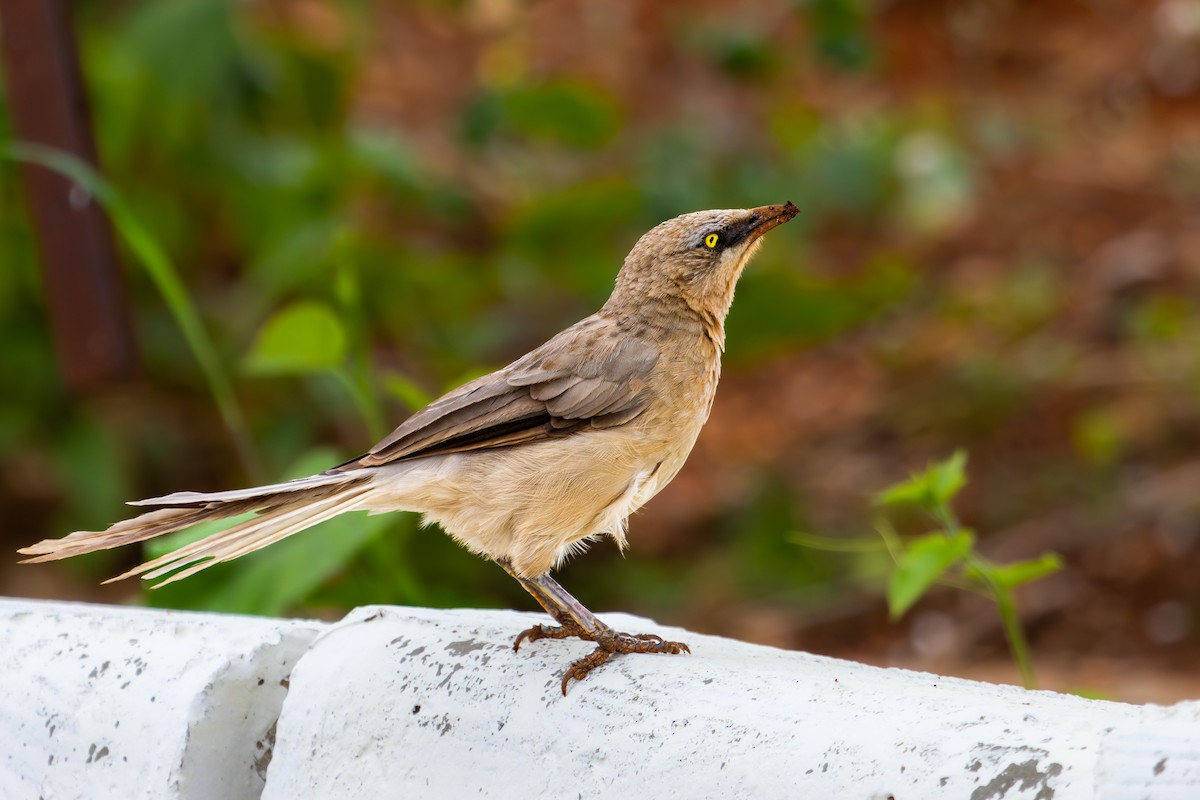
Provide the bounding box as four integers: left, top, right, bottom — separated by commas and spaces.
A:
500, 563, 691, 694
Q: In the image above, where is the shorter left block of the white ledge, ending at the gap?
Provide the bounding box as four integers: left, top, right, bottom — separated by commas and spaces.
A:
0, 600, 318, 800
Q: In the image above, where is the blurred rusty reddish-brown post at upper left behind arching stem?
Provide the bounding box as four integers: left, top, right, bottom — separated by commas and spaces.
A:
0, 0, 138, 390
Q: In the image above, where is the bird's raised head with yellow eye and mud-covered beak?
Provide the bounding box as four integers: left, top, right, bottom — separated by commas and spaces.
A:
608, 201, 799, 338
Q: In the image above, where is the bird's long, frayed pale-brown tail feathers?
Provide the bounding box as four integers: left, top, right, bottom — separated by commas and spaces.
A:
18, 470, 371, 587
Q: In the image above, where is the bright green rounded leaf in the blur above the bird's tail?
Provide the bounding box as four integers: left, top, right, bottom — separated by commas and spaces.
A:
244, 300, 347, 374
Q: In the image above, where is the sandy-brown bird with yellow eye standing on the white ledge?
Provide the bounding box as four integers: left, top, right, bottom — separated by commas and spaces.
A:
19, 201, 798, 696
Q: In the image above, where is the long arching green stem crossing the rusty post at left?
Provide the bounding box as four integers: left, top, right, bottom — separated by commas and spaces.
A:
0, 142, 264, 482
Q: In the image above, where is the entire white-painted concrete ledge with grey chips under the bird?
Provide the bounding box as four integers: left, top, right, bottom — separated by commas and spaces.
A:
0, 601, 1200, 800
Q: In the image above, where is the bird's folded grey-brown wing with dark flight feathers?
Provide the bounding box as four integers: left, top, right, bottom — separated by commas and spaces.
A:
338, 317, 659, 469
